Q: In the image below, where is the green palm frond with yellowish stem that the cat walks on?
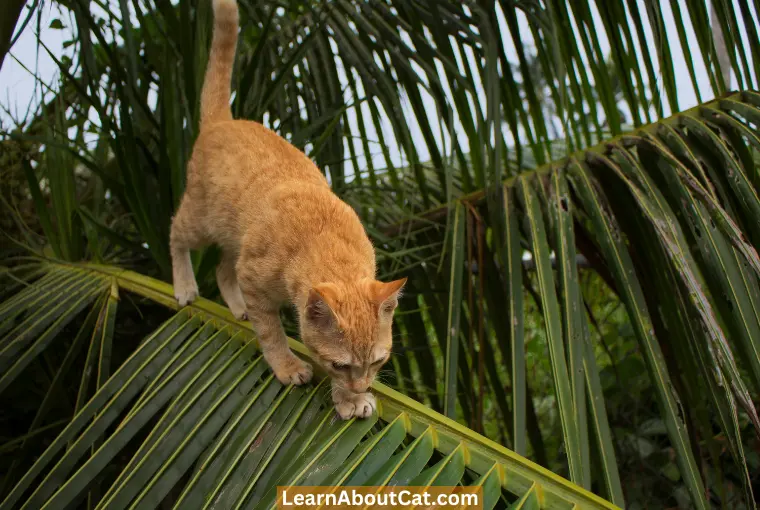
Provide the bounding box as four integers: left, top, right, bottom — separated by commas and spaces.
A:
0, 260, 615, 509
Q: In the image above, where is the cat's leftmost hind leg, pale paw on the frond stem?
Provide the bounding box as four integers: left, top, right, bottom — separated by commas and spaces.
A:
169, 193, 208, 306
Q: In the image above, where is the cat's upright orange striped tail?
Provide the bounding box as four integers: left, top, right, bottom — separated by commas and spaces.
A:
201, 0, 239, 125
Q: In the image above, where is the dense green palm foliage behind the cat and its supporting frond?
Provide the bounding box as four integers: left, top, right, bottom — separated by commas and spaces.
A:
0, 0, 760, 508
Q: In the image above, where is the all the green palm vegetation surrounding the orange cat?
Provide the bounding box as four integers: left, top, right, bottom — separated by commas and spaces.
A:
0, 0, 760, 509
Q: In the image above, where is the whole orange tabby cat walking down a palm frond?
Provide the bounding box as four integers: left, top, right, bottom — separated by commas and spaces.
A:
171, 0, 406, 419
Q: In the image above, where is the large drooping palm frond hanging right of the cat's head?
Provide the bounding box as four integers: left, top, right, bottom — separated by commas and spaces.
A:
376, 91, 760, 508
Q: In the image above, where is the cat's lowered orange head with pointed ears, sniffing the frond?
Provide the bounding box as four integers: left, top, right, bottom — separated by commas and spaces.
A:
300, 278, 406, 393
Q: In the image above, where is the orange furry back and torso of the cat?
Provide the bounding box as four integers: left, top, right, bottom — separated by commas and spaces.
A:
188, 120, 375, 285
